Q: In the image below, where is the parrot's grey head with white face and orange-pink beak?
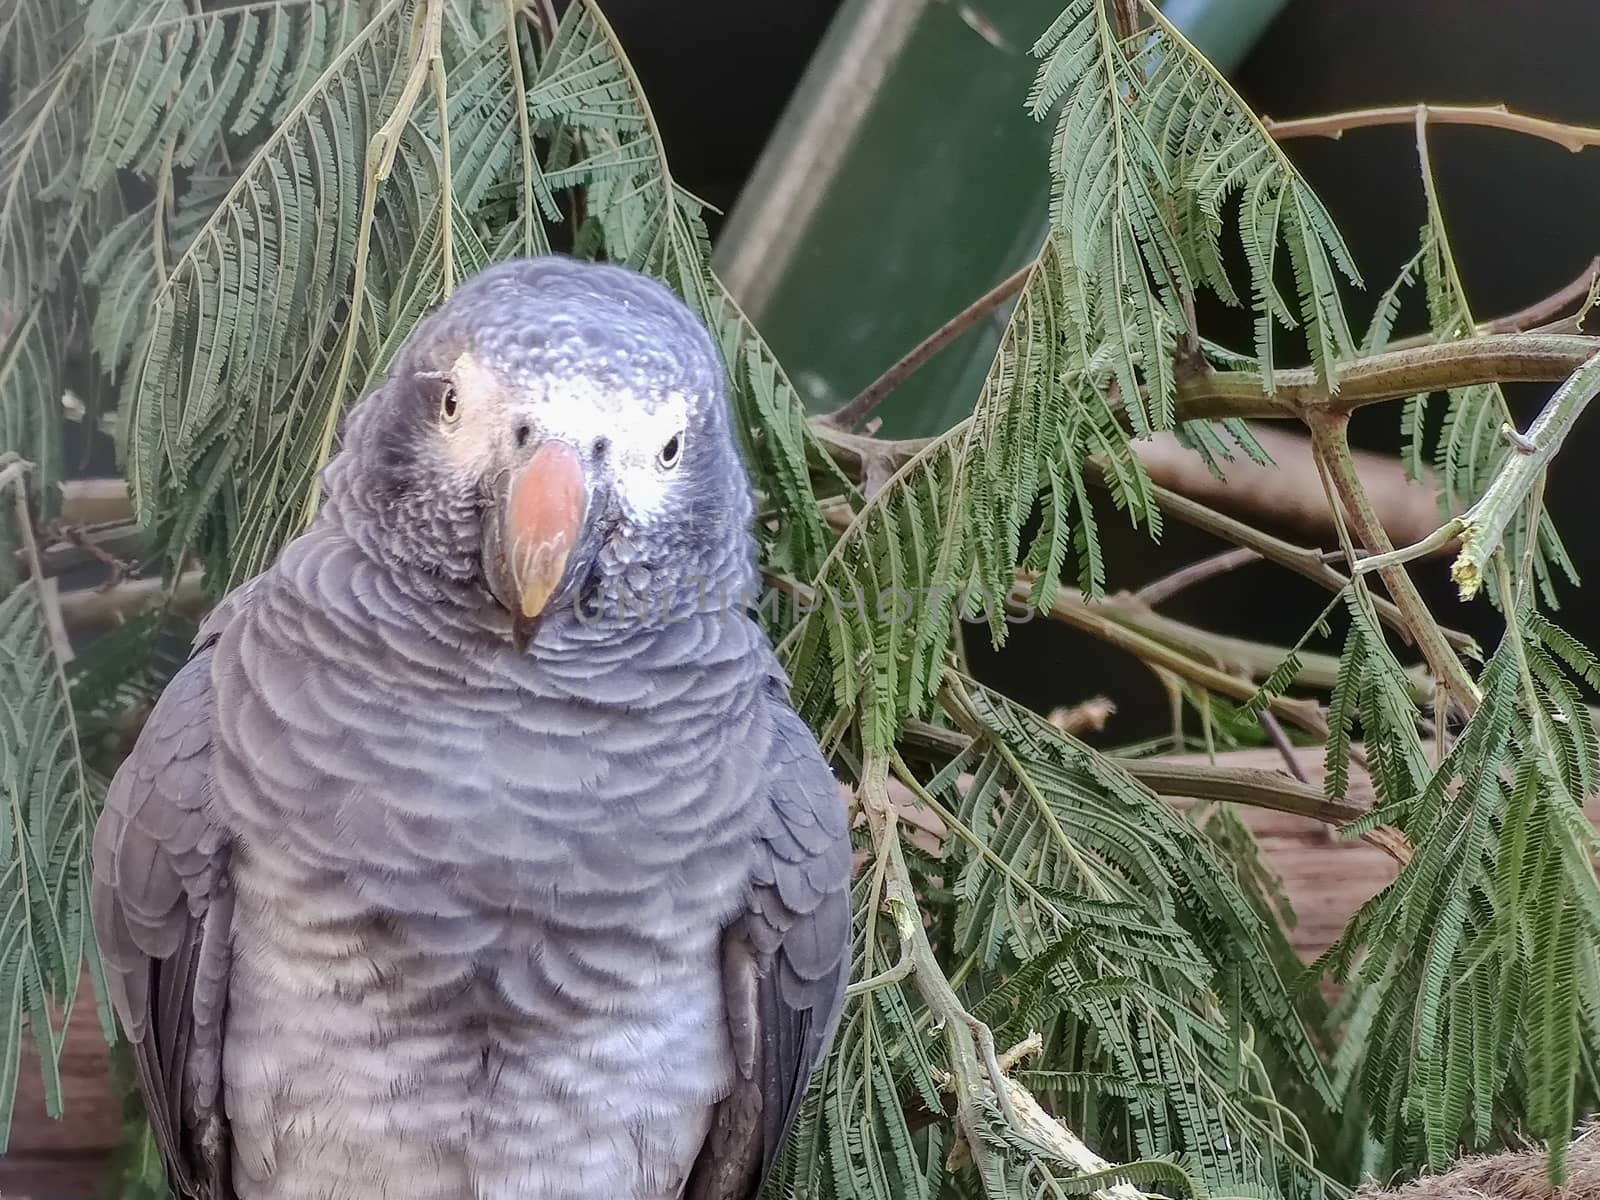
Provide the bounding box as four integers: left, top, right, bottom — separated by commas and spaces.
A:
328, 256, 754, 645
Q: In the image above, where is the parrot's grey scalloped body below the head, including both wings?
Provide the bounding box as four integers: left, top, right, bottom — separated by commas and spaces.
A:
93, 256, 850, 1200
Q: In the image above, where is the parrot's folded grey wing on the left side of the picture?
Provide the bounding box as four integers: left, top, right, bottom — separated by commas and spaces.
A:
93, 637, 232, 1200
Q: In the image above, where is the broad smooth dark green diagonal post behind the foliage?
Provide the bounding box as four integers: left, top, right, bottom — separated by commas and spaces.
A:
734, 0, 1282, 437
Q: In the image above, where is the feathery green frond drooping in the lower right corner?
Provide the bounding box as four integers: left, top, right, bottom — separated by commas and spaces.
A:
1328, 608, 1600, 1168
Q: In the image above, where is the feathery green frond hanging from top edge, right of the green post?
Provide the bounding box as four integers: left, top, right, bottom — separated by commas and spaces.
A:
1029, 0, 1360, 416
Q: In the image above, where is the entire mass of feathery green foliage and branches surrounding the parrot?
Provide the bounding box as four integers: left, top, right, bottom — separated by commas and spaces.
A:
9, 0, 1600, 1200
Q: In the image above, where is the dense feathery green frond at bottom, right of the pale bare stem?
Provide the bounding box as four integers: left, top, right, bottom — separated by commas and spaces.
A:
825, 682, 1342, 1197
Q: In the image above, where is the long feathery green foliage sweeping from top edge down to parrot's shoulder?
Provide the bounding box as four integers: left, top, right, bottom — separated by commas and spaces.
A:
787, 0, 1354, 746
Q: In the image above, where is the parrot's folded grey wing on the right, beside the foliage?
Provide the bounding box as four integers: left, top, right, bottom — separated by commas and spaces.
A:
685, 696, 850, 1200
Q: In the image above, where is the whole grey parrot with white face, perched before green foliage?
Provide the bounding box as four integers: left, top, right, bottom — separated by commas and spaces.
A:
93, 256, 851, 1200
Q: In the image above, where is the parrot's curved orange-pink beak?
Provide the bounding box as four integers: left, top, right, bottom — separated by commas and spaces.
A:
496, 442, 587, 624
